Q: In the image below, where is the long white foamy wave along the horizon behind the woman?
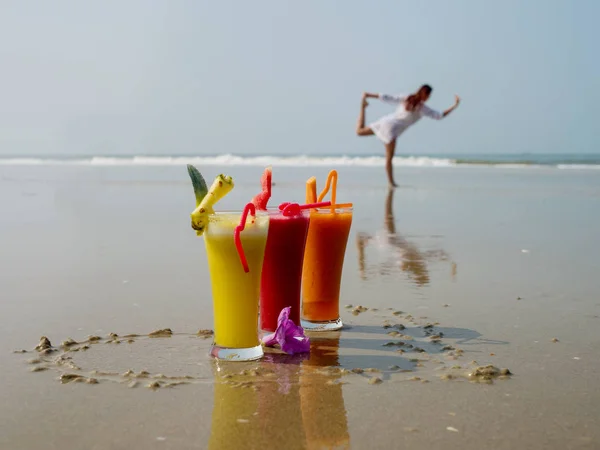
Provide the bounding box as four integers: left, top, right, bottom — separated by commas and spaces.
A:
0, 154, 600, 170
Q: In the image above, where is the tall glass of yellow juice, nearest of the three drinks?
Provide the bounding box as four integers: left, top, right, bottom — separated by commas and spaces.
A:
204, 211, 269, 361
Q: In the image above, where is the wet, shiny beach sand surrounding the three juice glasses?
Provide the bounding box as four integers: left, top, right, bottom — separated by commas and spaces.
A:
0, 166, 600, 450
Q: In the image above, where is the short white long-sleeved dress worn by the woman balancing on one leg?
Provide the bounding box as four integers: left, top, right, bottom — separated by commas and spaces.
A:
369, 94, 444, 144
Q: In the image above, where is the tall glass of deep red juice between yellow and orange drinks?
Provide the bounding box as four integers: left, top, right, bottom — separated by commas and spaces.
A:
260, 210, 310, 331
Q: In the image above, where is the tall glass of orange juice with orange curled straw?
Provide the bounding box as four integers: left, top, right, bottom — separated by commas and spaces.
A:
301, 170, 352, 331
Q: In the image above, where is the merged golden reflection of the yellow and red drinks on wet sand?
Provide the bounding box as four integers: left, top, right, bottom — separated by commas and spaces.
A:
209, 354, 307, 450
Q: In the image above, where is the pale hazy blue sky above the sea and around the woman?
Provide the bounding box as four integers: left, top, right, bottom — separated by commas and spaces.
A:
0, 0, 600, 155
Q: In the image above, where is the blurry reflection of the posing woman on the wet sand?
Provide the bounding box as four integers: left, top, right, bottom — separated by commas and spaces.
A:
356, 189, 457, 286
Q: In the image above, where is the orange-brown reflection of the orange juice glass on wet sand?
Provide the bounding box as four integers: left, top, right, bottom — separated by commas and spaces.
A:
300, 332, 350, 449
